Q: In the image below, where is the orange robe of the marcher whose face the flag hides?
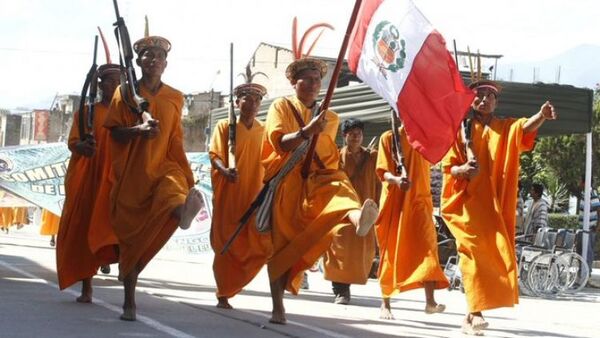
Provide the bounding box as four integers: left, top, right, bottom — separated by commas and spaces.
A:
375, 127, 449, 298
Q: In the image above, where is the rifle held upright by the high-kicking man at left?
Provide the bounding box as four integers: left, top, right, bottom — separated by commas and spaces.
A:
113, 0, 154, 124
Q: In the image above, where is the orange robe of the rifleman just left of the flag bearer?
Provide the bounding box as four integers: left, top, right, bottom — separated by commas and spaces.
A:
209, 120, 272, 298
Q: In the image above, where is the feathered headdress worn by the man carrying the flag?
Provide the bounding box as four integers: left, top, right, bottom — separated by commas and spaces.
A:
285, 17, 334, 81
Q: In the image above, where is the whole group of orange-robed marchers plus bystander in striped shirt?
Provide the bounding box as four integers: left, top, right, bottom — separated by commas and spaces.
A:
14, 19, 600, 335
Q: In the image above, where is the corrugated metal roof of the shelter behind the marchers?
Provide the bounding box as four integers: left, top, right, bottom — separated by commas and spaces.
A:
211, 81, 593, 143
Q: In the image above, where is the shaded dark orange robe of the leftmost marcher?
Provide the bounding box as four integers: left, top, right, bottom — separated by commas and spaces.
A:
56, 103, 117, 290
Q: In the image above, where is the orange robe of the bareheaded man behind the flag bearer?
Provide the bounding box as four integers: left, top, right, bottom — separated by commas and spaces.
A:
323, 147, 381, 284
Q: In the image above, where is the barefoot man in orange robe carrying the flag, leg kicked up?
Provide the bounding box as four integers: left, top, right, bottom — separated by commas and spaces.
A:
262, 58, 378, 324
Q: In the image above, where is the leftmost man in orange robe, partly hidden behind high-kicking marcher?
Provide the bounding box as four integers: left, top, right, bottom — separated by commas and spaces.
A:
56, 63, 120, 303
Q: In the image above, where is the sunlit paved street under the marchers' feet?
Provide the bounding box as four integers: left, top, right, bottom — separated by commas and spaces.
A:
0, 226, 600, 338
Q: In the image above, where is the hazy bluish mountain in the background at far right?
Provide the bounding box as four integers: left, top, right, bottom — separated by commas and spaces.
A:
496, 44, 600, 89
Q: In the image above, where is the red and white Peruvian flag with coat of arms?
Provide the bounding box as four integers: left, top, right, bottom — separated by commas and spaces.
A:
348, 0, 474, 163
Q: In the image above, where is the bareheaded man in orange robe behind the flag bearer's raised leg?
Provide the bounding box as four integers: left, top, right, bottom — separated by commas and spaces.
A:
323, 118, 381, 304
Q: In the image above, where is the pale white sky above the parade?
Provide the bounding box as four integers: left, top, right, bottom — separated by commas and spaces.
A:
0, 0, 600, 108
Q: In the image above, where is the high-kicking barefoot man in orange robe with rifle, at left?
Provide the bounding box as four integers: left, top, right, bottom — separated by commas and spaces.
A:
104, 36, 202, 321
